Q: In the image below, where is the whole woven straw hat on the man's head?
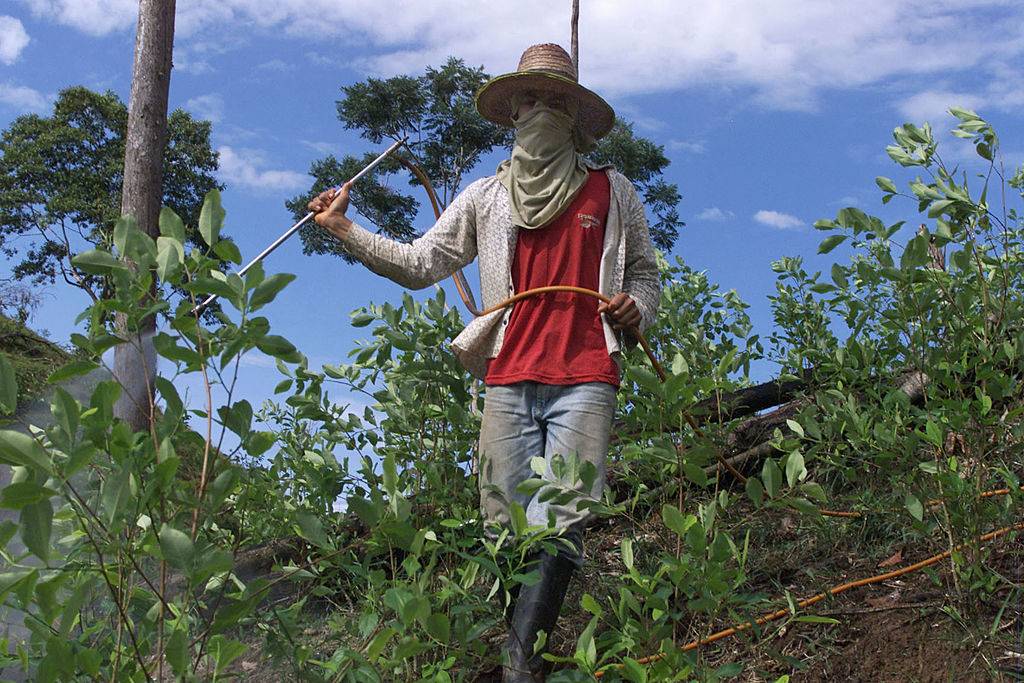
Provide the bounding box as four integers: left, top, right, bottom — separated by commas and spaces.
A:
476, 43, 615, 139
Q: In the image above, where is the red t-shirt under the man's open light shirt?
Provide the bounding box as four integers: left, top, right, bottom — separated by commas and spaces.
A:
484, 171, 618, 387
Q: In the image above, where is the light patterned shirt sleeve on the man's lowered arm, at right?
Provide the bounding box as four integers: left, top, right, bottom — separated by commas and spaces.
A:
623, 180, 662, 332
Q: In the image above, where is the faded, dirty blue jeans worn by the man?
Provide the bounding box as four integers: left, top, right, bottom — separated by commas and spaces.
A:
480, 382, 615, 561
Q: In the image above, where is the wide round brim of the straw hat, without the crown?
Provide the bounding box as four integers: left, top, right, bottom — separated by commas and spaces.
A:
476, 72, 615, 140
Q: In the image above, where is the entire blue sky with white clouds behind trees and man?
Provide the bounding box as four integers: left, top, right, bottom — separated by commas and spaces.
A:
0, 0, 1024, 417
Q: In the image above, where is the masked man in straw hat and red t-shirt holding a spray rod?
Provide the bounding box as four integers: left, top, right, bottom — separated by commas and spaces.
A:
309, 44, 659, 682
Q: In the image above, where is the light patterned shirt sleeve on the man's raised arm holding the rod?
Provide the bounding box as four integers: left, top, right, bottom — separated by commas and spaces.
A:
342, 183, 477, 290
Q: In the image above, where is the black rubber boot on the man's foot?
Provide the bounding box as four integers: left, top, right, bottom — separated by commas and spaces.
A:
502, 553, 577, 683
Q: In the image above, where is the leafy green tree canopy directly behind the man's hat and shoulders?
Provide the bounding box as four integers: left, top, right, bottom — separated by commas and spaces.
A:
286, 57, 684, 260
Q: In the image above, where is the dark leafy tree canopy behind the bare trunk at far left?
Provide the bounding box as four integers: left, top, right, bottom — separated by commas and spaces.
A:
0, 87, 223, 298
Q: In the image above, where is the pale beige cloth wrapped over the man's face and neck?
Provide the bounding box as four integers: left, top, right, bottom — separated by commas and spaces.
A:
498, 101, 587, 229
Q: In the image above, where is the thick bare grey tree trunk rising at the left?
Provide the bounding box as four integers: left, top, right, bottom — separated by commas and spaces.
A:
114, 0, 175, 430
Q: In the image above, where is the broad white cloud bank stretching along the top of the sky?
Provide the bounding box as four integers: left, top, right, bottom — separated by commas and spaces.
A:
23, 0, 1024, 110
